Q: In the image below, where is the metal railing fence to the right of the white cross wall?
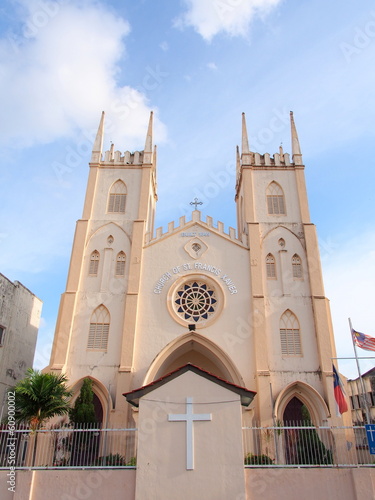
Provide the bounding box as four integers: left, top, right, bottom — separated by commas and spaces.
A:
243, 424, 375, 467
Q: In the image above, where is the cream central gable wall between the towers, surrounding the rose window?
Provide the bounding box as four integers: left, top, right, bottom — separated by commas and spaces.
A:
134, 223, 255, 390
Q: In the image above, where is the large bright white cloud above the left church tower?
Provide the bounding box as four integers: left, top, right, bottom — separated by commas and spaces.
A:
0, 1, 167, 148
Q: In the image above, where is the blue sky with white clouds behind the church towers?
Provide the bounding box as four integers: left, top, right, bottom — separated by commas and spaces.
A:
0, 0, 375, 378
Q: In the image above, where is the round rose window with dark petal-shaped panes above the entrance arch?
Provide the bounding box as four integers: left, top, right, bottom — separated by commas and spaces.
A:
174, 281, 217, 323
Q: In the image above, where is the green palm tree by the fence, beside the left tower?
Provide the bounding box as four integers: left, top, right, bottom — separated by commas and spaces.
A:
14, 368, 72, 465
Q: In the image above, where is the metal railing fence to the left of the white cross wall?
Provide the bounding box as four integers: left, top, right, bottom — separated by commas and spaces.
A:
0, 427, 136, 469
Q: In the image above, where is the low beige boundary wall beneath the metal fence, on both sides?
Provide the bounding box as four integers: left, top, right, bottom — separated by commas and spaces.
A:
0, 468, 375, 500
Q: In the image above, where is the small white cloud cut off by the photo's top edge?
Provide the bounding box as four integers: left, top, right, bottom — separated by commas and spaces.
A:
175, 0, 281, 41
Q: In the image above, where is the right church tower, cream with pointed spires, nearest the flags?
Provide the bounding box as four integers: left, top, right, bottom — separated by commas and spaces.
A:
236, 112, 335, 422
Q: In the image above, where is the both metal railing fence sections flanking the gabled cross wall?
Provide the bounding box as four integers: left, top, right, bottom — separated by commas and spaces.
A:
0, 424, 375, 469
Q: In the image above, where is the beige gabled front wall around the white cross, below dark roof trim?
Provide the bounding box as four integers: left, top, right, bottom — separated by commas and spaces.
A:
136, 372, 245, 500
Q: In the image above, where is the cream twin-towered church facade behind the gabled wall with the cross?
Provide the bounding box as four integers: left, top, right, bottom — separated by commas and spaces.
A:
47, 113, 342, 427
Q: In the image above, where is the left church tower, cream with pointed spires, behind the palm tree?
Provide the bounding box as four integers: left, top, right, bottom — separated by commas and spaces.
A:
49, 112, 157, 422
